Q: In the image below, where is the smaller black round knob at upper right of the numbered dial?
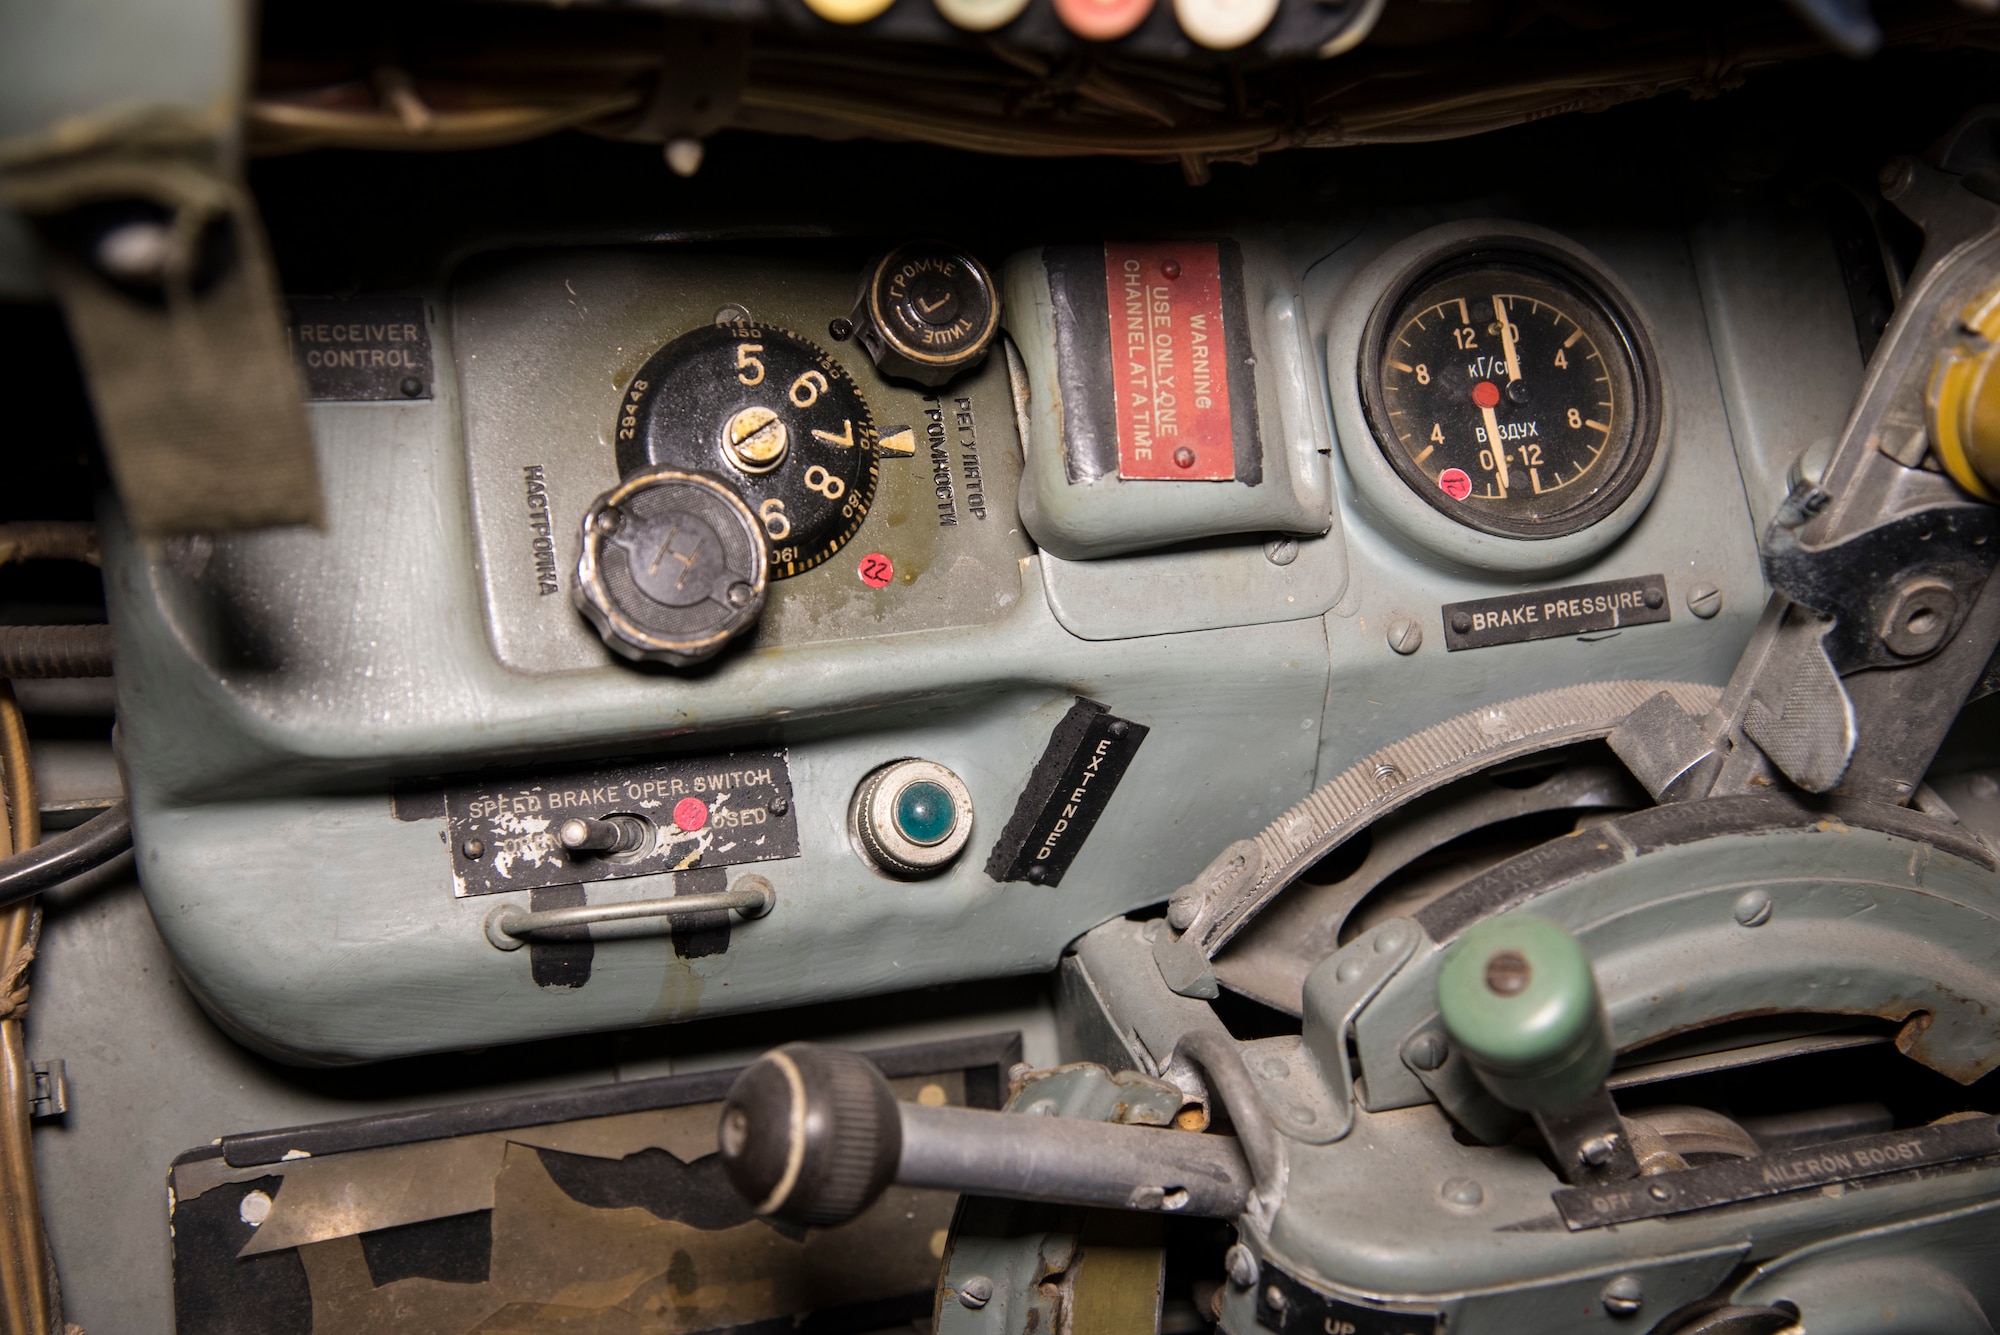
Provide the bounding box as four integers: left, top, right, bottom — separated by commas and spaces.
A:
854, 242, 1000, 388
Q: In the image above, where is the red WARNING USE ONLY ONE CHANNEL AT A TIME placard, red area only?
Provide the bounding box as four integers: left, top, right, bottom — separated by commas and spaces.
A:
1104, 242, 1236, 482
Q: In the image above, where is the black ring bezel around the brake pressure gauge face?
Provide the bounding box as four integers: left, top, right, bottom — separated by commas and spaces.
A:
1360, 236, 1660, 542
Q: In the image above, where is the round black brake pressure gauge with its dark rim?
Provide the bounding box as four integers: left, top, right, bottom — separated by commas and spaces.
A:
1362, 250, 1658, 538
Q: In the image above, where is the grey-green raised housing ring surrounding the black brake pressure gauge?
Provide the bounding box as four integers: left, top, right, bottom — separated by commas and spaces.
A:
1320, 218, 1676, 576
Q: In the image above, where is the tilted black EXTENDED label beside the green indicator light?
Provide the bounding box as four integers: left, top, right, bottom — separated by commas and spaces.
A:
986, 699, 1148, 885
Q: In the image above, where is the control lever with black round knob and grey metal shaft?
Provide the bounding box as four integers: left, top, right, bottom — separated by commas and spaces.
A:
720, 1043, 1252, 1225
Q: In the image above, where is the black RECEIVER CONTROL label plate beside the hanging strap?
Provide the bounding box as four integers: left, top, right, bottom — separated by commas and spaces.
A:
288, 296, 432, 402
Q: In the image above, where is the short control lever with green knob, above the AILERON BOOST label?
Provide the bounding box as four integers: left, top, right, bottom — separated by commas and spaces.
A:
1438, 913, 1638, 1185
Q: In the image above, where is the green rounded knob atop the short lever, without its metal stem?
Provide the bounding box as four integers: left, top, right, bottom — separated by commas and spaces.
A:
1438, 913, 1612, 1113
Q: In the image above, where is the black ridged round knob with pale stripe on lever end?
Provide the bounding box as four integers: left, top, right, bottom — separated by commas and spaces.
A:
720, 1043, 902, 1225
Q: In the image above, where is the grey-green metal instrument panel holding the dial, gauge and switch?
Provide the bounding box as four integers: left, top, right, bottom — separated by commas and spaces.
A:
106, 216, 1792, 1061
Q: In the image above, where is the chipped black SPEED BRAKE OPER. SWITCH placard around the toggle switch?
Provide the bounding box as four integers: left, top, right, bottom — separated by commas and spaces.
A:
444, 749, 798, 895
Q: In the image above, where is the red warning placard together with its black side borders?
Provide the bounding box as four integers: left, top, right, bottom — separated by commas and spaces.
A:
1042, 242, 1264, 486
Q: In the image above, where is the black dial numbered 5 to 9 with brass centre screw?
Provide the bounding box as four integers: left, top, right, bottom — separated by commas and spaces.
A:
618, 322, 880, 580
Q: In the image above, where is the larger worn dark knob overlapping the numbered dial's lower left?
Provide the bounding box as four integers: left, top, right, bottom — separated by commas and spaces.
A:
576, 468, 768, 668
